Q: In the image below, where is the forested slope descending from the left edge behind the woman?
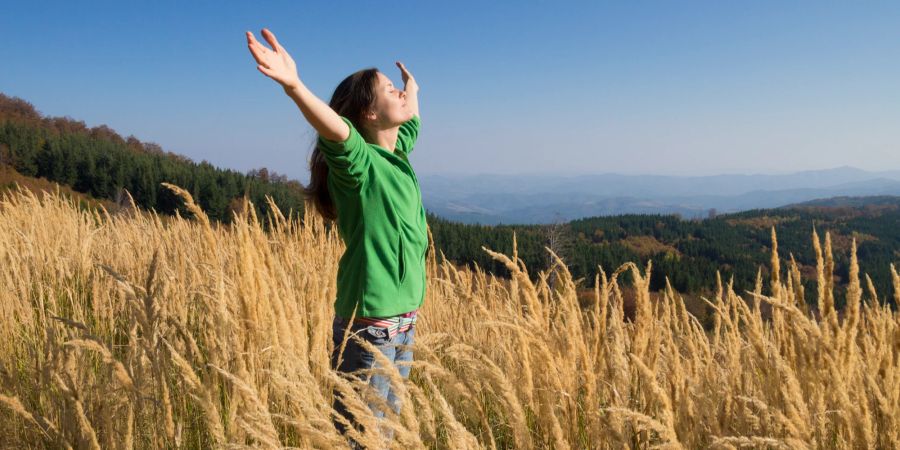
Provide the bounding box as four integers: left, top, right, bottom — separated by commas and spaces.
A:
0, 94, 303, 222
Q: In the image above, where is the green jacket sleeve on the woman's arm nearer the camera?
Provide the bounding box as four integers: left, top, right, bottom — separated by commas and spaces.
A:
318, 116, 372, 189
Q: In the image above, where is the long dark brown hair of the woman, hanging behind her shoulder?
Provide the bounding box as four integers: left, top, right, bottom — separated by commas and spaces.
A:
303, 67, 378, 221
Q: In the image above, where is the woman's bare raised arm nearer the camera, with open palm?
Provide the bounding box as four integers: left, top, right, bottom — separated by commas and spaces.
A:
247, 28, 350, 142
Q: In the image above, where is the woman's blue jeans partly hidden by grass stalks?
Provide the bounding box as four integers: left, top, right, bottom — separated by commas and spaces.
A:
331, 317, 415, 444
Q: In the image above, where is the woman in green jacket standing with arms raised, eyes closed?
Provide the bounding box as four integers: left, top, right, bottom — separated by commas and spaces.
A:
247, 29, 428, 442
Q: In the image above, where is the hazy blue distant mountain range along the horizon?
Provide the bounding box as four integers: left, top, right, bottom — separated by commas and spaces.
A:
419, 167, 900, 225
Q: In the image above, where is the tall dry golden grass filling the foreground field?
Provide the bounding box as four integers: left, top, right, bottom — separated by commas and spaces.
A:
0, 185, 900, 449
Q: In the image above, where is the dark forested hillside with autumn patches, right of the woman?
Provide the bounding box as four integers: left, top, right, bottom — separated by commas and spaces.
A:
428, 201, 900, 306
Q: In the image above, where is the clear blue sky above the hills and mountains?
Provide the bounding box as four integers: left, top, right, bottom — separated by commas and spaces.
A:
0, 0, 900, 185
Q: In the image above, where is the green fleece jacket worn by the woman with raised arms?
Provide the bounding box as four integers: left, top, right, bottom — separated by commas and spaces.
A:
318, 115, 428, 318
